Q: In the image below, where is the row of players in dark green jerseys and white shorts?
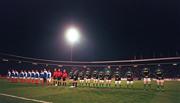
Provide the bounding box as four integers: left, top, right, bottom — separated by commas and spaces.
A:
69, 68, 164, 90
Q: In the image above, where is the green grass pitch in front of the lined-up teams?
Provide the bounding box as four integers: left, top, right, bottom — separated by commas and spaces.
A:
0, 79, 180, 103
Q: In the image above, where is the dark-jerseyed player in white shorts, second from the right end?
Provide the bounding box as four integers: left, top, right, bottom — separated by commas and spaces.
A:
143, 68, 151, 90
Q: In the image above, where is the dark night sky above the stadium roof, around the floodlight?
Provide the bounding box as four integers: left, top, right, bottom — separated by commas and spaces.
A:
0, 0, 180, 61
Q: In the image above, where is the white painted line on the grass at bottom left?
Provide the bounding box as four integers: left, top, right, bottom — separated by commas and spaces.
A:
0, 93, 52, 103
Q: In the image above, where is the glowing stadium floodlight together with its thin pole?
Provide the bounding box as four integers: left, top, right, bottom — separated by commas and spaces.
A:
65, 27, 80, 61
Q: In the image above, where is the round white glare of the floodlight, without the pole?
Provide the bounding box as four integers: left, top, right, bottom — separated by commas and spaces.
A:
66, 28, 79, 44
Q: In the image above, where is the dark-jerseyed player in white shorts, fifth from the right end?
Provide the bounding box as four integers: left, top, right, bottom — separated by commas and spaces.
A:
105, 66, 112, 87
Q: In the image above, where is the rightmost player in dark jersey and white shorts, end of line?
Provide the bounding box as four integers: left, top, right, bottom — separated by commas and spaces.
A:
156, 68, 164, 90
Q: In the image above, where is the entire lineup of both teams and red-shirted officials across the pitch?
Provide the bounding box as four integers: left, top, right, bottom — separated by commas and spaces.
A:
7, 66, 164, 90
